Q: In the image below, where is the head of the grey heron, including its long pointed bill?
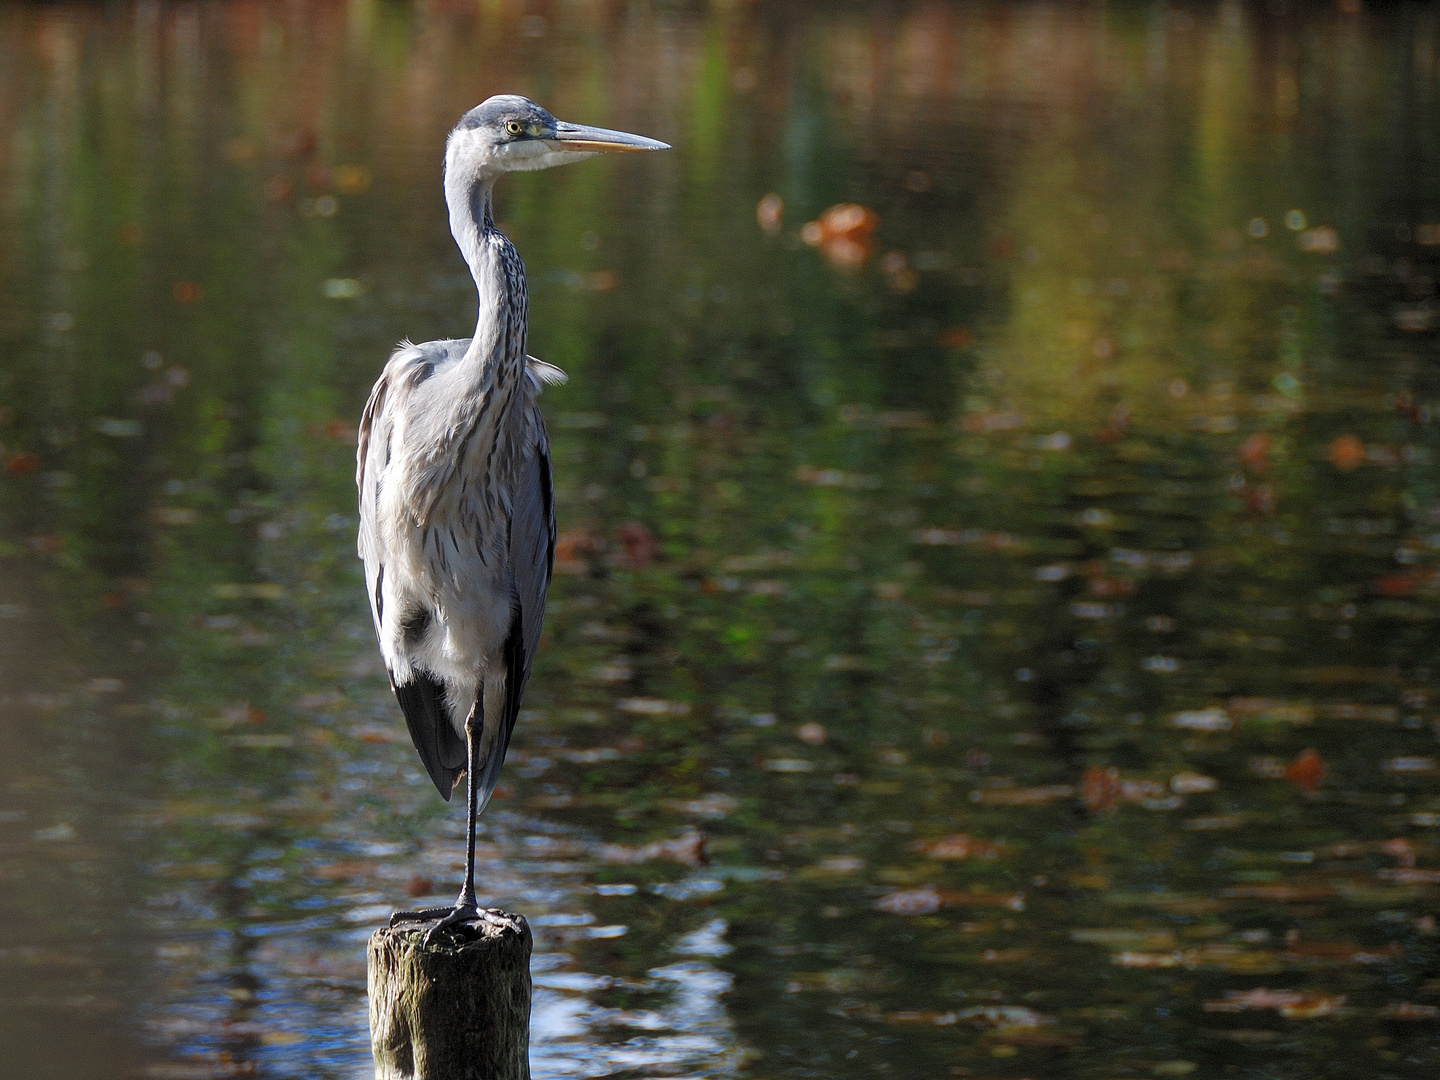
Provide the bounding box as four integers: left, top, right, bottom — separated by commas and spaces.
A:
445, 94, 670, 180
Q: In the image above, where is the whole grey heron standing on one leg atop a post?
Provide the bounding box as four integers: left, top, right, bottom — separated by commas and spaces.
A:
356, 95, 670, 940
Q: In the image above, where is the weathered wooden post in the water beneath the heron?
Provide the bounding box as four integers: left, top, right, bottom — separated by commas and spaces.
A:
369, 909, 530, 1080
